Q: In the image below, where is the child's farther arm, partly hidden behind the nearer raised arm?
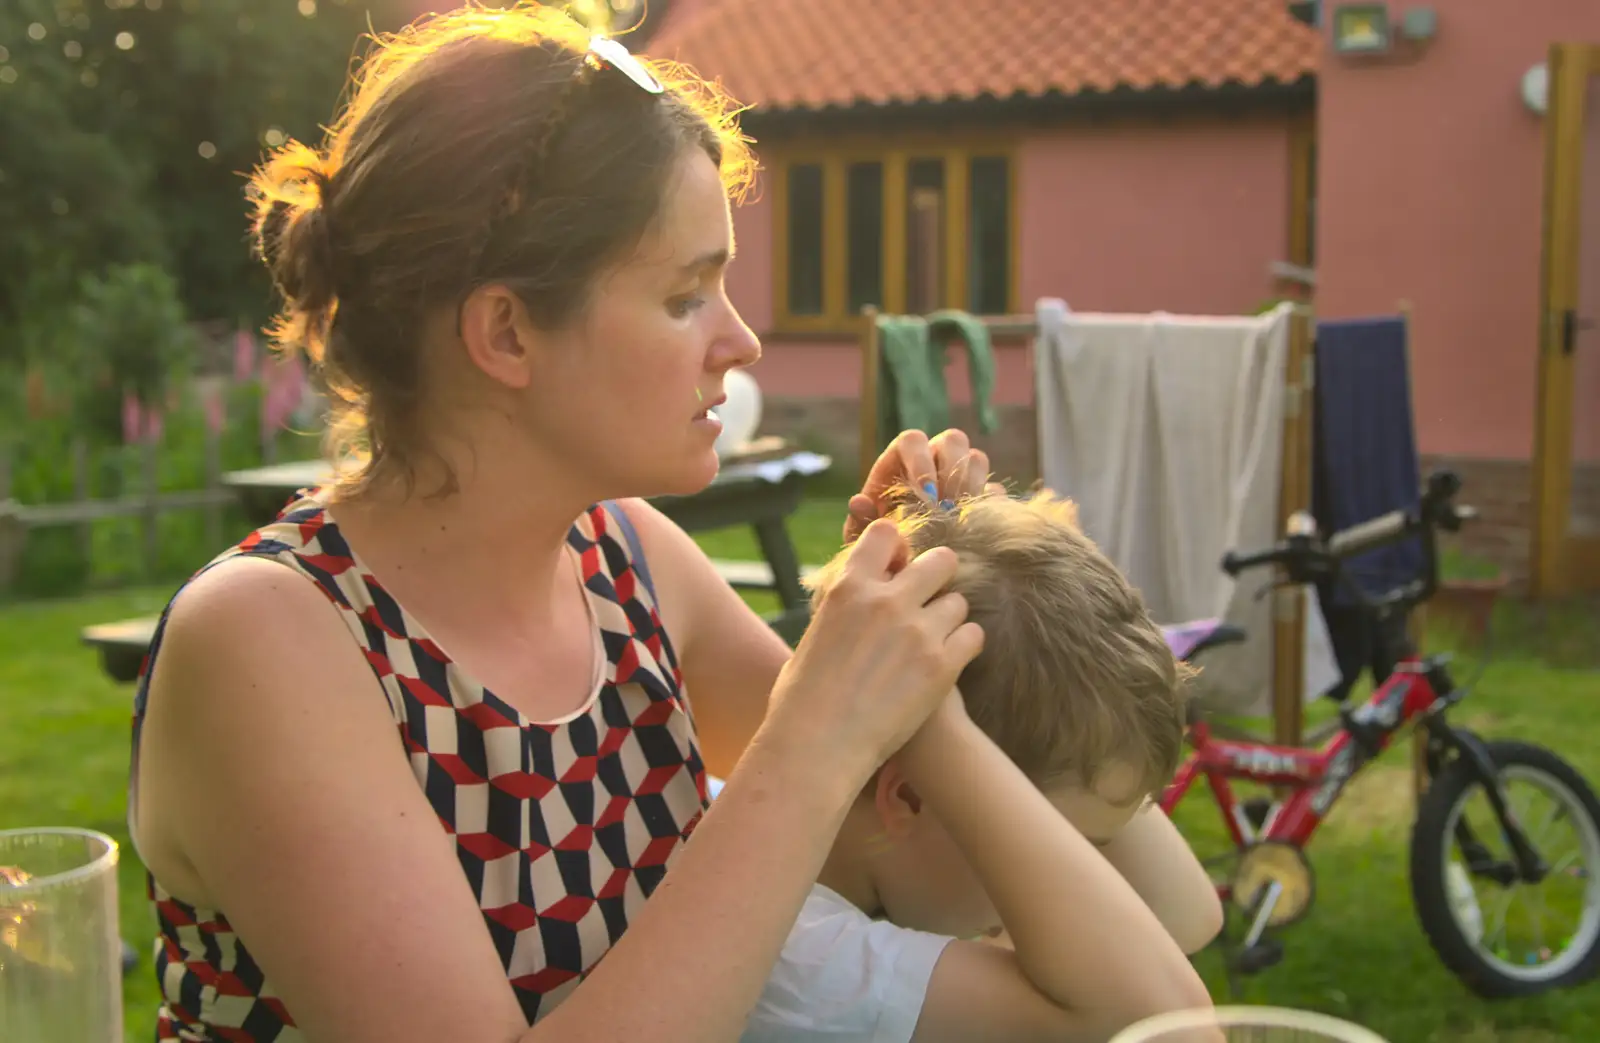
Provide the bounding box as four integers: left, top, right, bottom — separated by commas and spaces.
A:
1101, 805, 1222, 952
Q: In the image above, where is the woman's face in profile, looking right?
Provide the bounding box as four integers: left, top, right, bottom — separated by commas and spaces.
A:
525, 149, 762, 496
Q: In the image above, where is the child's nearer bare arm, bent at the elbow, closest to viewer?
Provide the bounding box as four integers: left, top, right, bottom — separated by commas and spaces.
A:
899, 697, 1211, 1043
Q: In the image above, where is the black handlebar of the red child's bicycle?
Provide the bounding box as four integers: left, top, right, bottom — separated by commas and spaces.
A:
1222, 470, 1477, 601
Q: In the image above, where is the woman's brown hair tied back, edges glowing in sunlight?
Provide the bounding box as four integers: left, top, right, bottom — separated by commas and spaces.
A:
248, 3, 754, 488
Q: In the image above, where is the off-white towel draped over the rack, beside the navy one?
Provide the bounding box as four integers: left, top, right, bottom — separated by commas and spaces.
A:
1035, 299, 1338, 713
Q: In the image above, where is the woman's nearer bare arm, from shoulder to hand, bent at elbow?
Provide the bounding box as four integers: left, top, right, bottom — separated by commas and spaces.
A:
147, 526, 981, 1043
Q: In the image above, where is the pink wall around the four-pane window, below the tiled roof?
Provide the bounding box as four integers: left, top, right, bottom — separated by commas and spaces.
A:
728, 117, 1290, 407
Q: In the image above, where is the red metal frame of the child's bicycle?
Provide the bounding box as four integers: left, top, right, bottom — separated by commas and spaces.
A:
1160, 651, 1442, 848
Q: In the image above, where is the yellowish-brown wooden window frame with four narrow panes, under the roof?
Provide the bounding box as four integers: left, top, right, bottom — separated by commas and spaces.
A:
762, 138, 1022, 336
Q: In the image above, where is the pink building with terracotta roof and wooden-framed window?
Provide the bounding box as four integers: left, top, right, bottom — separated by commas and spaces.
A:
648, 0, 1600, 585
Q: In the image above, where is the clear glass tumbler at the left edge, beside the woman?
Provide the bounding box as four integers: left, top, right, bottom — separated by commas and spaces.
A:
0, 829, 123, 1043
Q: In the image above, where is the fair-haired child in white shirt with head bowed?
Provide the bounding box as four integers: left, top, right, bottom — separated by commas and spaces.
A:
744, 493, 1222, 1043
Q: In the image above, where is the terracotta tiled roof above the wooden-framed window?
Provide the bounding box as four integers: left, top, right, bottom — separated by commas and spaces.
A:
646, 0, 1322, 109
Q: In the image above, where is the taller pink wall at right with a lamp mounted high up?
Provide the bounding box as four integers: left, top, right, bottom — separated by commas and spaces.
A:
1317, 0, 1600, 461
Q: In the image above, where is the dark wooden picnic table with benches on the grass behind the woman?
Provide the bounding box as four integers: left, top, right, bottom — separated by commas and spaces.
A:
82, 440, 832, 683
